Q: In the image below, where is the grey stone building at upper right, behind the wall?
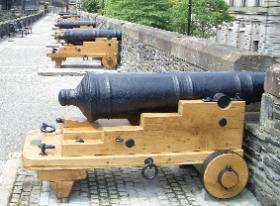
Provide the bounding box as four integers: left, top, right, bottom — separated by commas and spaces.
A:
215, 0, 280, 58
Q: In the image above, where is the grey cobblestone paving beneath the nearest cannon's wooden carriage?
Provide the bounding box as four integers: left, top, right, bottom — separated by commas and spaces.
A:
9, 167, 202, 206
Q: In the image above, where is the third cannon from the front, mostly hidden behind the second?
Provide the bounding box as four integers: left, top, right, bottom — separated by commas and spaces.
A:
53, 21, 96, 40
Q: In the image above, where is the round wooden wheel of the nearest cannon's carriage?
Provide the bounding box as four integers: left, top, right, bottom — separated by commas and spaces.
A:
202, 151, 249, 199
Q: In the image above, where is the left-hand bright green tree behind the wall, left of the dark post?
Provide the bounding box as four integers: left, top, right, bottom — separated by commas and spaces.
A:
101, 0, 170, 29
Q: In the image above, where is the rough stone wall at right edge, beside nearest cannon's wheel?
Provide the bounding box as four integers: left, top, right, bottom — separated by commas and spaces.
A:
244, 65, 280, 206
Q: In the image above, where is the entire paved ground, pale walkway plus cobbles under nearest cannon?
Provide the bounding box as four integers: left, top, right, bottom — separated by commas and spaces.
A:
0, 15, 258, 206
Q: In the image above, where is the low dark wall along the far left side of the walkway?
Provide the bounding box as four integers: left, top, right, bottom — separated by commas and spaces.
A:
0, 12, 44, 39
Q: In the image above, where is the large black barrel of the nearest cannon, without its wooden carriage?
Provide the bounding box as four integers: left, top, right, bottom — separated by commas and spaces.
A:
59, 72, 265, 122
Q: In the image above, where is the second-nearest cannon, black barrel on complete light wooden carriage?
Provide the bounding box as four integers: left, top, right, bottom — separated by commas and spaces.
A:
47, 29, 121, 69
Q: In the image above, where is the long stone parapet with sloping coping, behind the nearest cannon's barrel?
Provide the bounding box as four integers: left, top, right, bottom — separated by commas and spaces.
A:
78, 12, 275, 72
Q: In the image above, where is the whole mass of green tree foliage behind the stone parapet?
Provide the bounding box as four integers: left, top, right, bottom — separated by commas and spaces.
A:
82, 0, 233, 38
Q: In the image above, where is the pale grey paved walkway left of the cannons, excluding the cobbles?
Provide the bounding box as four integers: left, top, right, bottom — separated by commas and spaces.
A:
0, 15, 96, 168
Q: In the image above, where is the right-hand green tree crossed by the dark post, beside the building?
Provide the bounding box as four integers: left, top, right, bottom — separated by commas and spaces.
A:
170, 0, 234, 38
